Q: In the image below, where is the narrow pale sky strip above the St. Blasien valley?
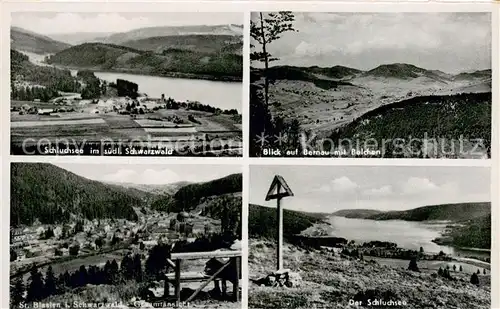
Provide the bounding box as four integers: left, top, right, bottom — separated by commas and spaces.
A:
56, 163, 242, 184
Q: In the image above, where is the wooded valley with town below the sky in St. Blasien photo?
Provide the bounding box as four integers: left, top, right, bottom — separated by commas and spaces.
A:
10, 163, 242, 308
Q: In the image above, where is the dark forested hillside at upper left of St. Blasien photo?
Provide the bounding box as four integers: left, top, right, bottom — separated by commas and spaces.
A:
10, 163, 145, 226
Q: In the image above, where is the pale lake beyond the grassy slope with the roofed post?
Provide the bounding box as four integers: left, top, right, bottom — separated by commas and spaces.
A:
329, 216, 490, 257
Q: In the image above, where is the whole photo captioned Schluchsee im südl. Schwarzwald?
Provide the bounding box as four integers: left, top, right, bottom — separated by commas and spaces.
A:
10, 12, 244, 157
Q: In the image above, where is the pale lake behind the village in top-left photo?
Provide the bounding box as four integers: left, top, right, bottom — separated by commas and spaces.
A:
72, 70, 243, 112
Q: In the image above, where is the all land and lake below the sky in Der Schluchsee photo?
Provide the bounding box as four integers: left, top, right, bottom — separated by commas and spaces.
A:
249, 203, 491, 308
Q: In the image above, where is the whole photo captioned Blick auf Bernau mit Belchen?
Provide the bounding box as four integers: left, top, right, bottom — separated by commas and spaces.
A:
249, 12, 492, 159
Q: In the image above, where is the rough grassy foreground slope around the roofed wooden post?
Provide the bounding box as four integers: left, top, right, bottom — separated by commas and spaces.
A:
248, 239, 491, 309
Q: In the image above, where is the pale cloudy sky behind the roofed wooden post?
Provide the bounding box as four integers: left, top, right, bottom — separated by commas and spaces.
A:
249, 165, 491, 213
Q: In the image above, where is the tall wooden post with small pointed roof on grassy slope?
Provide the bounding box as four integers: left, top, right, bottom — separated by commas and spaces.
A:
266, 175, 293, 270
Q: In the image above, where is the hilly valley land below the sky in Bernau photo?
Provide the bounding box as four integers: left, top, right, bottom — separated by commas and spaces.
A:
253, 63, 491, 158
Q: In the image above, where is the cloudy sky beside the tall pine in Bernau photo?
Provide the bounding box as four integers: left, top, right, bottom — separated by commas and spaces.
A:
252, 12, 491, 74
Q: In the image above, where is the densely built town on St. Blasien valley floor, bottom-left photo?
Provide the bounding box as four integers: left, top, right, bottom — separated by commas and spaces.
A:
10, 212, 220, 277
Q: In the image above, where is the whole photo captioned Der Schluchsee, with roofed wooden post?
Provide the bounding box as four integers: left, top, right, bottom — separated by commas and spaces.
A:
248, 165, 491, 309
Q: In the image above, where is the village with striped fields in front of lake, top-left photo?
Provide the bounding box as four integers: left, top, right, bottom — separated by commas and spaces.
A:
10, 76, 242, 155
